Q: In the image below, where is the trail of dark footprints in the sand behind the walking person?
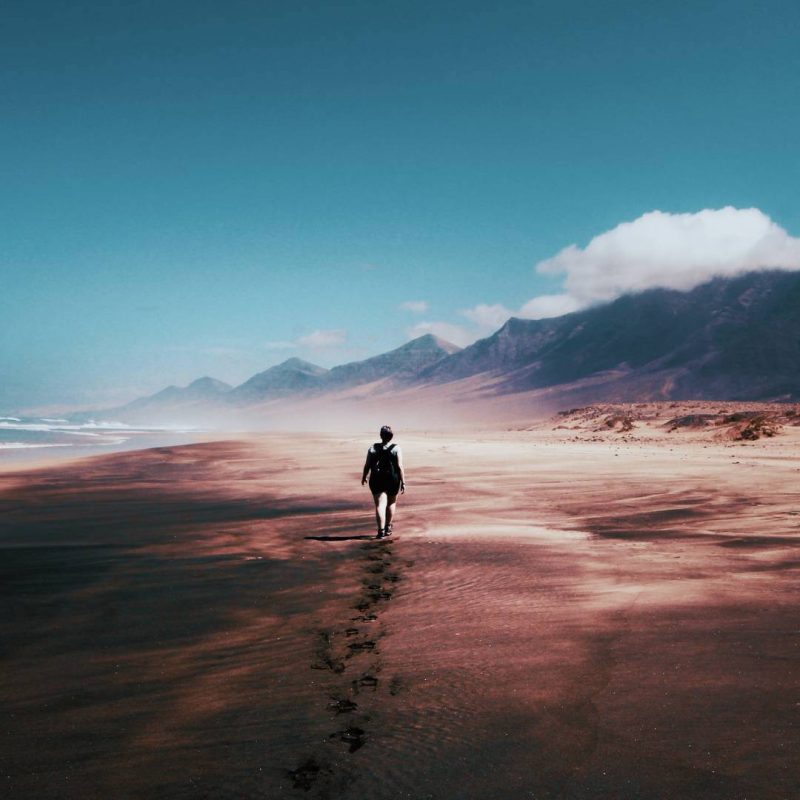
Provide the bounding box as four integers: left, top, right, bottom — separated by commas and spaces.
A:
288, 539, 413, 797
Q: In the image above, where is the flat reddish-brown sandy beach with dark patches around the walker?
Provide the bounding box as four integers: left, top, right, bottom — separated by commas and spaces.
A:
0, 433, 800, 800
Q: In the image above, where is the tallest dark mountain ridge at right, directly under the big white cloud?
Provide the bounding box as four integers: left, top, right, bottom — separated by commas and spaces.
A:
420, 271, 800, 401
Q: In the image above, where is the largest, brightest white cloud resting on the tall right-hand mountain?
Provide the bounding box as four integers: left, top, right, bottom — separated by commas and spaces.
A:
523, 206, 800, 317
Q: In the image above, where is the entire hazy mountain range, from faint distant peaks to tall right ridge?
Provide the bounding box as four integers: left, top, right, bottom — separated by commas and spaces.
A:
80, 271, 800, 422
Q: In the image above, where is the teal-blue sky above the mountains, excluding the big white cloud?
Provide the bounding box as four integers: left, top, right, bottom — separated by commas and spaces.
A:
0, 0, 800, 411
